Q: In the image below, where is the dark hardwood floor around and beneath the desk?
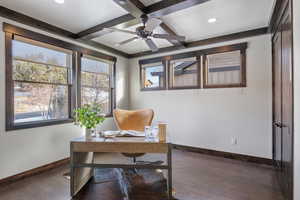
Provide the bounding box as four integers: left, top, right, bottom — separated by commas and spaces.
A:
0, 150, 283, 200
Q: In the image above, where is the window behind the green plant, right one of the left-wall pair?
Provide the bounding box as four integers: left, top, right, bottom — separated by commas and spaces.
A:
81, 55, 114, 115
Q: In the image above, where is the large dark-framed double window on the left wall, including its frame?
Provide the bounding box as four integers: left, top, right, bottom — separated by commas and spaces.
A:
3, 23, 116, 131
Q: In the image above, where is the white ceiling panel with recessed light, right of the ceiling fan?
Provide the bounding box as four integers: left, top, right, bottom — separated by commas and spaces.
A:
163, 0, 274, 41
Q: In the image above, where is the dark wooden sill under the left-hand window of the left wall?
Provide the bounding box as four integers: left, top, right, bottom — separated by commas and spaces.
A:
6, 119, 74, 131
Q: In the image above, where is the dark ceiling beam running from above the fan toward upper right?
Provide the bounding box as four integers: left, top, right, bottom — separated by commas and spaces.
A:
143, 0, 210, 17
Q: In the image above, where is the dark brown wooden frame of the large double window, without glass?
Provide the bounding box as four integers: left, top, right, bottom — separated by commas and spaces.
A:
3, 23, 117, 131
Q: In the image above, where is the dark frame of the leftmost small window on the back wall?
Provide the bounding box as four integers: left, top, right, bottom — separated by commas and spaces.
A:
139, 60, 167, 91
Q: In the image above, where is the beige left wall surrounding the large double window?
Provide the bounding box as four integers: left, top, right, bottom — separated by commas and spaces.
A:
0, 18, 128, 179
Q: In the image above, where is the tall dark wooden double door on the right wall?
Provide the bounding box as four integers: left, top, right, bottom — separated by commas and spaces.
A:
273, 1, 293, 200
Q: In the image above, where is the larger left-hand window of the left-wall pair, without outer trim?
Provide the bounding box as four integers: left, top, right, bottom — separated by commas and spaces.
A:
12, 36, 72, 126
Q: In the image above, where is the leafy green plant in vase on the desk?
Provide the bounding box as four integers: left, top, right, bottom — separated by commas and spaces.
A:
74, 104, 105, 138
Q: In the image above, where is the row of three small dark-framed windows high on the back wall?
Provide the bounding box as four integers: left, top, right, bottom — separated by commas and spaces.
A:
139, 43, 247, 91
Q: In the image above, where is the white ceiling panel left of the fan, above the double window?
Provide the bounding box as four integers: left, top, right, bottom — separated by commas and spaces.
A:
0, 0, 127, 33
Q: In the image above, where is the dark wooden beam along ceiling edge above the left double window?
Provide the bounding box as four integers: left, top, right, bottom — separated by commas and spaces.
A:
0, 6, 129, 58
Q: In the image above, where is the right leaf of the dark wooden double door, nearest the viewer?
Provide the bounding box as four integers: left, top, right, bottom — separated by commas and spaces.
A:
282, 12, 293, 199
